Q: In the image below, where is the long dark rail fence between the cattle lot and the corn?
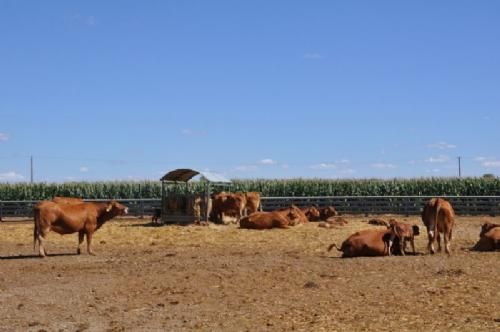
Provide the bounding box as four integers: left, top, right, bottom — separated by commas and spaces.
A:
0, 196, 500, 218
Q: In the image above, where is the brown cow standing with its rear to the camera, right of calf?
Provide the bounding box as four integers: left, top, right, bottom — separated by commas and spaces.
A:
422, 198, 455, 255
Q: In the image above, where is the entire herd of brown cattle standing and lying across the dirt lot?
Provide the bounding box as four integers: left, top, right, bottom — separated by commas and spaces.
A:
26, 192, 500, 257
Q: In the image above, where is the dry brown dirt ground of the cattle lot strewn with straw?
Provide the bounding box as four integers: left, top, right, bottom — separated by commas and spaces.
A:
0, 216, 500, 331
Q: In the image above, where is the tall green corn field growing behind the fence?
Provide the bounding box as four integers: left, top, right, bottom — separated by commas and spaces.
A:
0, 178, 500, 201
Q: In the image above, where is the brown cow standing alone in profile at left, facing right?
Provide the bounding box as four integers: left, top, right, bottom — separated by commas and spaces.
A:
33, 201, 128, 257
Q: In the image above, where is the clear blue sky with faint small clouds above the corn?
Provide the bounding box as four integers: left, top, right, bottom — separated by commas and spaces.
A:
0, 0, 500, 182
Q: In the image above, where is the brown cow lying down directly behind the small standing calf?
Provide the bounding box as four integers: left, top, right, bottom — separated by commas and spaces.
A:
328, 229, 399, 258
